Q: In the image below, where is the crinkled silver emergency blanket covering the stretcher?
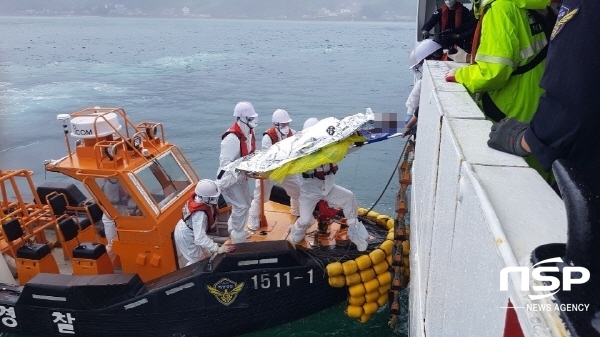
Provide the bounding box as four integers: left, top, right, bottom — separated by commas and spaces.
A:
225, 108, 375, 174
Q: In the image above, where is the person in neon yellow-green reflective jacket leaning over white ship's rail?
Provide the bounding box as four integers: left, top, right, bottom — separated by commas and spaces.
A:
446, 0, 550, 122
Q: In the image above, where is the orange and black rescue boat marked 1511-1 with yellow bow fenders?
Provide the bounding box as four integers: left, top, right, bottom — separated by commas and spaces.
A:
0, 107, 406, 337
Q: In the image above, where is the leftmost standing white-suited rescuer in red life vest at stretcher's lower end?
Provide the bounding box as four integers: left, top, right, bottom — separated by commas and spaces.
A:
216, 102, 258, 243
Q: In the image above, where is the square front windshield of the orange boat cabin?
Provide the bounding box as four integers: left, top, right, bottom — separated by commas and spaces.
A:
136, 152, 192, 209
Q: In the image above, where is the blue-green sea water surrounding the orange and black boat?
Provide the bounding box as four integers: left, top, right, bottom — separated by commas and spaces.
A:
0, 17, 415, 337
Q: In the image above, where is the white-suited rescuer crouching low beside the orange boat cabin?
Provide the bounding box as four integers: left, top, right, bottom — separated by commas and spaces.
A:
174, 179, 235, 266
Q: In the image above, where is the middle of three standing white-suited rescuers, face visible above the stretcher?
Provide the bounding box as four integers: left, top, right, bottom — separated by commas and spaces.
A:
248, 109, 300, 231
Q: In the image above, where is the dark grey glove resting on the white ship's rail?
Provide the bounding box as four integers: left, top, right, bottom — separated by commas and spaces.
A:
488, 118, 529, 157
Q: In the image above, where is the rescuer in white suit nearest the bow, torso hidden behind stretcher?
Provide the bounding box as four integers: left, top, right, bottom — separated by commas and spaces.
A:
289, 117, 369, 251
